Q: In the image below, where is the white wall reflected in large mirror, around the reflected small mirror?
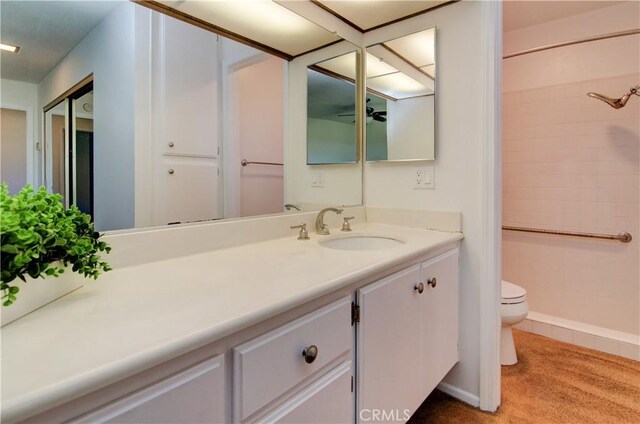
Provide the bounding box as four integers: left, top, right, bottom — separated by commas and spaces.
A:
285, 42, 362, 205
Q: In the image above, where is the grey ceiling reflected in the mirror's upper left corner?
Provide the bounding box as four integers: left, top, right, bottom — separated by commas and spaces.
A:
0, 0, 120, 83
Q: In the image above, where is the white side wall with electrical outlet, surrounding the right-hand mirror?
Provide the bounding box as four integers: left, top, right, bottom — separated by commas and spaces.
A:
364, 2, 500, 408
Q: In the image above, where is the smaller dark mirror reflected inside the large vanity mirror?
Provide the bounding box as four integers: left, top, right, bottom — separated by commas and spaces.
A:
307, 52, 358, 165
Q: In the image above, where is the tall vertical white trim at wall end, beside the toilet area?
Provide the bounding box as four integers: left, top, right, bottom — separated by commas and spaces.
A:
479, 1, 502, 411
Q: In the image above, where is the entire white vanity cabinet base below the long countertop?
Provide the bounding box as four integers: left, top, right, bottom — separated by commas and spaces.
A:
7, 244, 459, 424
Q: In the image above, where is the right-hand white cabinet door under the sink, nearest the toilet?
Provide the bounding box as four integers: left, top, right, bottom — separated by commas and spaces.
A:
422, 249, 459, 396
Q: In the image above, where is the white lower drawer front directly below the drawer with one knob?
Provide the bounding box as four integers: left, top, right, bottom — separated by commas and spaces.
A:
258, 361, 354, 424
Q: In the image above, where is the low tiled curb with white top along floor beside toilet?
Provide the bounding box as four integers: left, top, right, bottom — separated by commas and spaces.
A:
514, 311, 640, 361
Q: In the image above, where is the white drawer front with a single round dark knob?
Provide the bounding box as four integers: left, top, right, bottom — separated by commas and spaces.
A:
233, 298, 352, 422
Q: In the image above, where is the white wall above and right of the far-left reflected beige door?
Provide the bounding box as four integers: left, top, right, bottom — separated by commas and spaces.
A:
0, 79, 37, 187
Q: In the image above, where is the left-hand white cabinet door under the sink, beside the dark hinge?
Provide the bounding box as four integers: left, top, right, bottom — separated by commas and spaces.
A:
357, 265, 425, 421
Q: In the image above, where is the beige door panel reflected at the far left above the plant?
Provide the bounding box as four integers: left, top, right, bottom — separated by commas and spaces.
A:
0, 108, 27, 194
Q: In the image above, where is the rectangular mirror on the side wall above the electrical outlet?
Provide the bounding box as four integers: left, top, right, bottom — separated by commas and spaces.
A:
365, 27, 436, 162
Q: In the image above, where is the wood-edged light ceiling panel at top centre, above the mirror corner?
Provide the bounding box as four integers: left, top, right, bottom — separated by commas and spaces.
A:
317, 0, 448, 32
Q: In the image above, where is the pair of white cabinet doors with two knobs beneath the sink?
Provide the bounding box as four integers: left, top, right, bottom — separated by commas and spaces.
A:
357, 249, 458, 422
